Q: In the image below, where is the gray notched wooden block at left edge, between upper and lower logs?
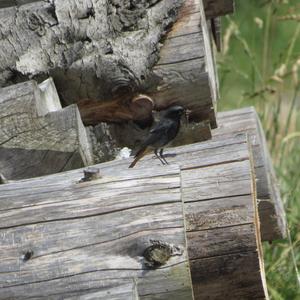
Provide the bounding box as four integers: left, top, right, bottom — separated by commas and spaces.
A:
0, 79, 93, 179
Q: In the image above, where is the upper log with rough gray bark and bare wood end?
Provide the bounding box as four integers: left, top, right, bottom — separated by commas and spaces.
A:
0, 0, 218, 134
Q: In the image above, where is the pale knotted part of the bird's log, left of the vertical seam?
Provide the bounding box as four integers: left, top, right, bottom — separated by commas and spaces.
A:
0, 164, 193, 300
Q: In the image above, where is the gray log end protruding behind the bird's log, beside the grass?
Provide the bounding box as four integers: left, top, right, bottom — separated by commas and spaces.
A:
213, 107, 286, 241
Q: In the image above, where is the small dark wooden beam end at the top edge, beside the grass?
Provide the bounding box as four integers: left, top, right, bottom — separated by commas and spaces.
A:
203, 0, 234, 19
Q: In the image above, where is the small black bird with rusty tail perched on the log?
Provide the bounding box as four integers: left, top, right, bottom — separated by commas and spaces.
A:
129, 105, 185, 168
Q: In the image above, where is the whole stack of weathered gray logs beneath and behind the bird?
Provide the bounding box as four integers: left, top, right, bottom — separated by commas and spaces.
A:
0, 0, 286, 300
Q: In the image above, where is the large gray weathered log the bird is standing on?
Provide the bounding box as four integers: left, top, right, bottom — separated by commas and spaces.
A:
0, 120, 267, 299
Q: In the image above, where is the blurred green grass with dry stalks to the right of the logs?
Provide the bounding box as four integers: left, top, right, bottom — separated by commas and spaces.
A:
218, 0, 300, 300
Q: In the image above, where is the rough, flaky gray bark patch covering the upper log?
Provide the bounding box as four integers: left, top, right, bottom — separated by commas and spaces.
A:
0, 0, 183, 104
